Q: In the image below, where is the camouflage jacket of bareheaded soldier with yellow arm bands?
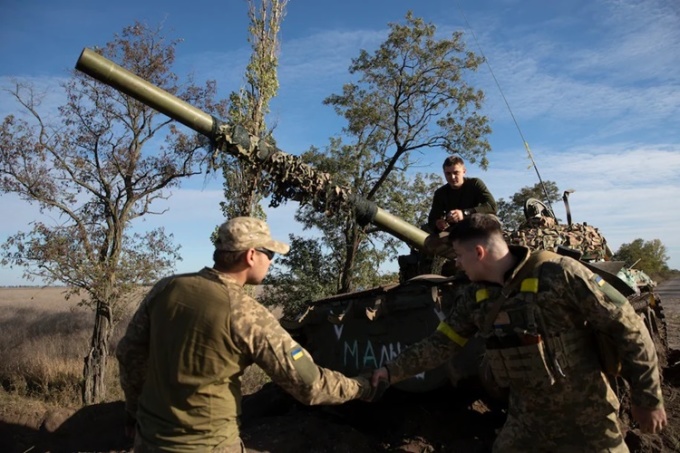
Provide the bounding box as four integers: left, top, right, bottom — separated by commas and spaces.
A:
388, 246, 662, 411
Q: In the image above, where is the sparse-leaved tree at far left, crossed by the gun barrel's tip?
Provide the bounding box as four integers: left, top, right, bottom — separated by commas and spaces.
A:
0, 23, 226, 403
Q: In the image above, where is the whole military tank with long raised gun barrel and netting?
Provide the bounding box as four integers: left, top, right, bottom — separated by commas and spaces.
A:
76, 49, 662, 392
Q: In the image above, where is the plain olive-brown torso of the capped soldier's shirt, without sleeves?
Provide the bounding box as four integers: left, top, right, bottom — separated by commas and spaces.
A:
137, 271, 246, 451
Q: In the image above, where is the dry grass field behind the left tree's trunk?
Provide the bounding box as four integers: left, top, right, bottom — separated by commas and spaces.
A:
0, 287, 267, 420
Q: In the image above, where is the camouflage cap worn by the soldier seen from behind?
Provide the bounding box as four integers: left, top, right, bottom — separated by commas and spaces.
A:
215, 217, 290, 255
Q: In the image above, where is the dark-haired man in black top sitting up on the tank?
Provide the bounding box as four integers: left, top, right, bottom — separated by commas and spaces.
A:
427, 156, 496, 233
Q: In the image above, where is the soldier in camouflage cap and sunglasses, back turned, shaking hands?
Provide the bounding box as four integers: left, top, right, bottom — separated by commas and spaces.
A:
116, 217, 372, 452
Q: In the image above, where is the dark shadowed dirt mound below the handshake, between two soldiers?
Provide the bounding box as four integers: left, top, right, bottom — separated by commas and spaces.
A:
242, 383, 505, 453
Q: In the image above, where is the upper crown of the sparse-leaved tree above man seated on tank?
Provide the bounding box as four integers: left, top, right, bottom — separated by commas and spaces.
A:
324, 11, 491, 177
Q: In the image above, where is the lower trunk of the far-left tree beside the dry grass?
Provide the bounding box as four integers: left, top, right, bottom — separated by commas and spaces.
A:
82, 301, 111, 404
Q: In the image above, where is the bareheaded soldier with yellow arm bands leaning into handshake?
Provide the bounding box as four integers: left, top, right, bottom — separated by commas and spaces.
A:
372, 214, 667, 452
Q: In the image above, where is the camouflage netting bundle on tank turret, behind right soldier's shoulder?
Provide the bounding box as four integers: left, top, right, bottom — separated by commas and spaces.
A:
504, 217, 612, 261
